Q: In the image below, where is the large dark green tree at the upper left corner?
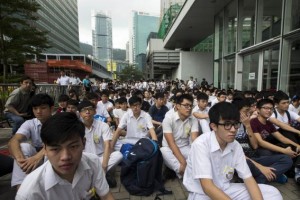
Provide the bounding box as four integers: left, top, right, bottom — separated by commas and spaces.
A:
0, 0, 50, 82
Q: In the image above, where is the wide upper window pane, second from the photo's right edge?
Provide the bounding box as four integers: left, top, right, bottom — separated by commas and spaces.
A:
262, 0, 282, 41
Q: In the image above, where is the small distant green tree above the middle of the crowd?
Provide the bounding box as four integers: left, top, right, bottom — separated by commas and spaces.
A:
117, 65, 143, 81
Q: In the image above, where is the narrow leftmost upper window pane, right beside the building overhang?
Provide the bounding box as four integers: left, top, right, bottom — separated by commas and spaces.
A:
225, 1, 237, 54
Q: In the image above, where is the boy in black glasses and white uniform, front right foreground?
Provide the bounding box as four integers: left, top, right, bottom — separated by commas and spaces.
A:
183, 102, 282, 200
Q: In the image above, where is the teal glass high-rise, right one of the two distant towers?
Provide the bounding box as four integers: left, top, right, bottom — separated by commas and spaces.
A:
129, 11, 159, 69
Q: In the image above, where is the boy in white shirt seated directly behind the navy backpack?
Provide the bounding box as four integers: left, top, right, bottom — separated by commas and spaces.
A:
111, 96, 157, 148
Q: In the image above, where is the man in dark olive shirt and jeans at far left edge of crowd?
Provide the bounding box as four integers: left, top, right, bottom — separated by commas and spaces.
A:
4, 75, 32, 135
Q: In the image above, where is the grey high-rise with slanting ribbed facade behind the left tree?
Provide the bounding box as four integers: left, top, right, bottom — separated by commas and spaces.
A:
36, 0, 80, 54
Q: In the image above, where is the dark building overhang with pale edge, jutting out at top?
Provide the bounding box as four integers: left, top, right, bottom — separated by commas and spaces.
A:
163, 0, 232, 49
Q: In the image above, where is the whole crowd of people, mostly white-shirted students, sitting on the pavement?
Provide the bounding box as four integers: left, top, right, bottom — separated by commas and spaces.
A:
1, 73, 300, 199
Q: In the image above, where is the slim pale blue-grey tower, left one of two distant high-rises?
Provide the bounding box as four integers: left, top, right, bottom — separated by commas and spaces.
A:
92, 11, 113, 67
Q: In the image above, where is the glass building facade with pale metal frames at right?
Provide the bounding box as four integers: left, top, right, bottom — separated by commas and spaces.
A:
214, 0, 300, 96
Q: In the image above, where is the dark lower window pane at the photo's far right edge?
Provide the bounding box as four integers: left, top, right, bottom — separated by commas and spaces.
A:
289, 40, 300, 96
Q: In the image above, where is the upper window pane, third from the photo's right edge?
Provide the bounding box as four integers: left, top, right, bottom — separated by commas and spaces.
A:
240, 0, 255, 48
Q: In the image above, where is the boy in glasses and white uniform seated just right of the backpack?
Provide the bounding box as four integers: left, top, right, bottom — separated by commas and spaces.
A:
160, 94, 199, 178
